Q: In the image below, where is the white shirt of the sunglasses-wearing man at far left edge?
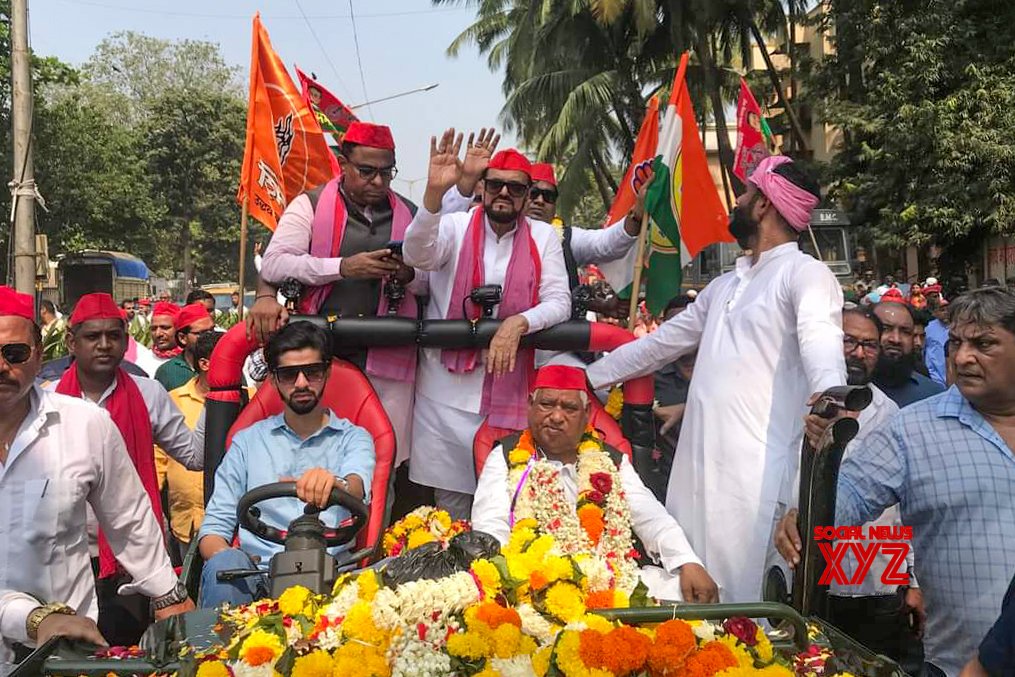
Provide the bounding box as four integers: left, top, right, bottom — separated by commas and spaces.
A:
0, 386, 177, 673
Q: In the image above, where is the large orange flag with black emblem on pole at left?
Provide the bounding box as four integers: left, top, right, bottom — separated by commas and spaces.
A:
236, 13, 338, 230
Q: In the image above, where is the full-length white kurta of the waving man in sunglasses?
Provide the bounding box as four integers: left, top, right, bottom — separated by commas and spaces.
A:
402, 207, 570, 493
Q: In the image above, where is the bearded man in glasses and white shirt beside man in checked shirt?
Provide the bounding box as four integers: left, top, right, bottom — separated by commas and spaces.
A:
774, 308, 926, 674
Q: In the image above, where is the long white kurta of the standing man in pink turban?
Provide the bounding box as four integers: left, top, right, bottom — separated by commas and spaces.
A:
588, 243, 845, 602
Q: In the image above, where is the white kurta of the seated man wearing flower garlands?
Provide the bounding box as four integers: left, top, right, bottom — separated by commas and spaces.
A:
472, 445, 701, 601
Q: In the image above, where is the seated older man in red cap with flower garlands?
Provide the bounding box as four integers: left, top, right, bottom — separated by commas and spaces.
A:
472, 365, 719, 603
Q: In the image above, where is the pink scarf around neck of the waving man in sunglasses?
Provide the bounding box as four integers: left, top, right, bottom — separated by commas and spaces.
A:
441, 207, 542, 430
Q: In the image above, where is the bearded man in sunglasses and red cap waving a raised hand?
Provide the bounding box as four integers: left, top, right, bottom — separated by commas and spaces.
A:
404, 129, 570, 518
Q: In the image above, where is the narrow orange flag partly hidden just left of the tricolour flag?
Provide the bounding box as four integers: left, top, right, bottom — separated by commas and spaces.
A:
599, 96, 659, 298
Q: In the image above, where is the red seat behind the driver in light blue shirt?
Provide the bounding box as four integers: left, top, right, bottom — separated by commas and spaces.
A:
225, 359, 395, 548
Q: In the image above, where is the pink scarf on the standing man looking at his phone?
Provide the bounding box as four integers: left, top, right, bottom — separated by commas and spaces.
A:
299, 179, 416, 383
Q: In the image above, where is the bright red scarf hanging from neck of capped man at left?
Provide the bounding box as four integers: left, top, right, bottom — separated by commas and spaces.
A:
57, 364, 162, 579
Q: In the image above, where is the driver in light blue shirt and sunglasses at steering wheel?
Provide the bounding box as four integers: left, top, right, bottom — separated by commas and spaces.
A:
198, 322, 375, 607
